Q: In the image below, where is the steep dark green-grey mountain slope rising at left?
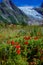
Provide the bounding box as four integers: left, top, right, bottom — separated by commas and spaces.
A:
0, 0, 29, 24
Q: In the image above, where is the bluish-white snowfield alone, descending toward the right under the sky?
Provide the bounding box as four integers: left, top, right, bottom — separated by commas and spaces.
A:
19, 6, 43, 20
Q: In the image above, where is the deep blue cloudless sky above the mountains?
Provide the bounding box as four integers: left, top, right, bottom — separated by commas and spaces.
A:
0, 0, 43, 6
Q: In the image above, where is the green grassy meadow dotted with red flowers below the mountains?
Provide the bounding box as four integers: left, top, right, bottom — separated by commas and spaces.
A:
0, 24, 43, 65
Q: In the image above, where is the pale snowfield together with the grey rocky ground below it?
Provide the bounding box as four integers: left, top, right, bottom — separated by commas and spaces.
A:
19, 6, 43, 24
